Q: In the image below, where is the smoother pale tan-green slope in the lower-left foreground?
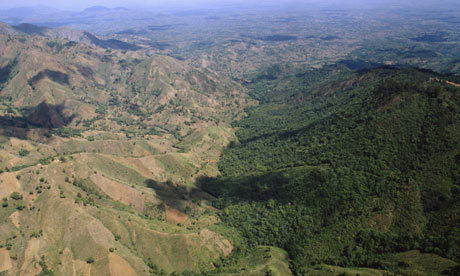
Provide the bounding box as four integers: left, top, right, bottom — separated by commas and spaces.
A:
0, 130, 237, 275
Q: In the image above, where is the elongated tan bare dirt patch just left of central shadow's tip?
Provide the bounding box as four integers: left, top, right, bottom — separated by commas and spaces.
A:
90, 174, 145, 212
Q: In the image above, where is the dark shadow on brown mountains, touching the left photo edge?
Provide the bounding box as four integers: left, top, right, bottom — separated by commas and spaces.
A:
0, 102, 76, 139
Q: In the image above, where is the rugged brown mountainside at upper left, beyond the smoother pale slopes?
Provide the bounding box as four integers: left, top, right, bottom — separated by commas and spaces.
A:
0, 35, 249, 138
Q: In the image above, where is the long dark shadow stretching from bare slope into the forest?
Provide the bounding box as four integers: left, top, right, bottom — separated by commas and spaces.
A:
144, 167, 318, 210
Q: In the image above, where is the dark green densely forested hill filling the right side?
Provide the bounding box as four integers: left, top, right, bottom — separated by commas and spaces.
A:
202, 68, 460, 275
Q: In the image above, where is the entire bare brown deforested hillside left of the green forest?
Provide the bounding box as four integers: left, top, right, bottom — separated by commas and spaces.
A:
0, 35, 252, 275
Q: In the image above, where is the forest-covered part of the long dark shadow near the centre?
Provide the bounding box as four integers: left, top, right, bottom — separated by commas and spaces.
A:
190, 171, 342, 226
